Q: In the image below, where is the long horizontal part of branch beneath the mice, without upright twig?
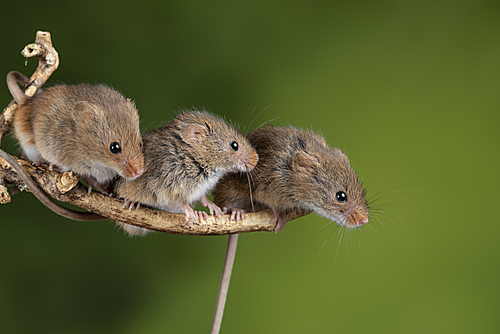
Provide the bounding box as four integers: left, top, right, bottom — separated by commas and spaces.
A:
0, 157, 308, 235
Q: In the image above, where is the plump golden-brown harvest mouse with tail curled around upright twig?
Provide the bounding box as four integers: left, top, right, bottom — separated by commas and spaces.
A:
7, 72, 144, 193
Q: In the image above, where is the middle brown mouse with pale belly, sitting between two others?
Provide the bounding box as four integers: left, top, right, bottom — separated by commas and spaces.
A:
115, 111, 258, 235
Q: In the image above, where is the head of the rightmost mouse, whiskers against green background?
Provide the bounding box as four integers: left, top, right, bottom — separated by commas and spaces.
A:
290, 132, 369, 227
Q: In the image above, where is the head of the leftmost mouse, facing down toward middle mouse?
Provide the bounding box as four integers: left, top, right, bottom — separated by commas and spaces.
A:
75, 85, 144, 179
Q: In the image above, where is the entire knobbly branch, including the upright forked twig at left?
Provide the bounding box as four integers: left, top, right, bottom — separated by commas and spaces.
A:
0, 31, 309, 235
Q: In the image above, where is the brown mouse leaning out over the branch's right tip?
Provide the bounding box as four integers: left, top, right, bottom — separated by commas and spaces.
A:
214, 126, 369, 232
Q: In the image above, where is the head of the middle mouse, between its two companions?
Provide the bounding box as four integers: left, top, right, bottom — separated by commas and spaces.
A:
176, 111, 258, 172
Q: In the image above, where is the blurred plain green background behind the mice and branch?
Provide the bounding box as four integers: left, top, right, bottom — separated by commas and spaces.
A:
0, 0, 500, 333
